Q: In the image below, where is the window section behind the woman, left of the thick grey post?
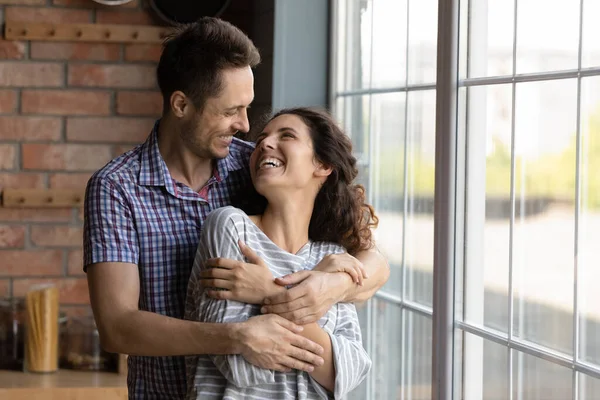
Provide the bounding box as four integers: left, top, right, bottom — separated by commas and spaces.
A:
331, 0, 437, 400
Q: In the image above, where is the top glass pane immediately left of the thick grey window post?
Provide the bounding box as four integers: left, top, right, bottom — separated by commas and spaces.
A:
406, 0, 438, 84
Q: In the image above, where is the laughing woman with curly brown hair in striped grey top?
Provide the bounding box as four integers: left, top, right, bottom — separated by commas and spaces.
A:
186, 108, 377, 399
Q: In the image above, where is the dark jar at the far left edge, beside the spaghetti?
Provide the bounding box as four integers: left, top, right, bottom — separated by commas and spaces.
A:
0, 298, 25, 370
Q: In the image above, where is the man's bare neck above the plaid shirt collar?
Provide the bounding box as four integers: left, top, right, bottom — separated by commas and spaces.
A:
158, 117, 215, 192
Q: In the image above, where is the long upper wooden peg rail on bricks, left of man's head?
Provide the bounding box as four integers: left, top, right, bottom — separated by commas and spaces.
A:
4, 20, 170, 43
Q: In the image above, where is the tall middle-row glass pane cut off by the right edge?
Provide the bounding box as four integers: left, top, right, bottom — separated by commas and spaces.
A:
570, 77, 600, 366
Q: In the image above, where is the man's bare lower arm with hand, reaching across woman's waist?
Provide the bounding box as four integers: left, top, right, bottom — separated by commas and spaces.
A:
88, 263, 322, 370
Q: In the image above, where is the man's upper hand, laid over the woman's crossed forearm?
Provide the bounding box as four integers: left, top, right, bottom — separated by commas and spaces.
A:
261, 270, 356, 325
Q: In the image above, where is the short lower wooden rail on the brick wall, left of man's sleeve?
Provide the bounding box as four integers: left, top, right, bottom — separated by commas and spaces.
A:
2, 188, 85, 208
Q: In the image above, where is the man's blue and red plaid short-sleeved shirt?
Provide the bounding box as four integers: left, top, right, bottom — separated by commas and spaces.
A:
84, 121, 254, 400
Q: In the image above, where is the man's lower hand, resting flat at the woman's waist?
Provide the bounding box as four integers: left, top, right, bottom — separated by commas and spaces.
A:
239, 315, 324, 372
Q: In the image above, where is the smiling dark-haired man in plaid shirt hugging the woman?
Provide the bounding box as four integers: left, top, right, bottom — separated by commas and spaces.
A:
84, 18, 389, 399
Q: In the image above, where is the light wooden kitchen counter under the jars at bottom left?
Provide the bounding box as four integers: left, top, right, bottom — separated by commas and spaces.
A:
0, 370, 127, 400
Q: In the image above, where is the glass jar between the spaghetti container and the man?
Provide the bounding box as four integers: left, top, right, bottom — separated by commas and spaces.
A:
60, 315, 117, 372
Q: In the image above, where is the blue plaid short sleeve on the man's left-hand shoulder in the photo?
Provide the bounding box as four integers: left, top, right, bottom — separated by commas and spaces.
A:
83, 177, 139, 271
